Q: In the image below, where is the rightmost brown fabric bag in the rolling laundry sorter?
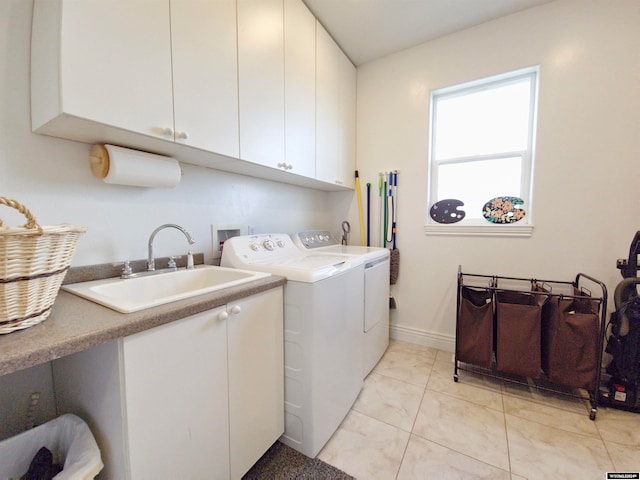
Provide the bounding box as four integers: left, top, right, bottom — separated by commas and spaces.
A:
542, 292, 600, 390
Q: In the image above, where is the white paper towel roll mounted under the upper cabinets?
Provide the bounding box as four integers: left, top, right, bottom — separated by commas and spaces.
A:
91, 145, 182, 187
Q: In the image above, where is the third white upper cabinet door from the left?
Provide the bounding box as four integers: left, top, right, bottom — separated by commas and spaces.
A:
238, 0, 284, 168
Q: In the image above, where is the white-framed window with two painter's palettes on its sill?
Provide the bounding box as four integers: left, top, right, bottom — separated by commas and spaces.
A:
425, 67, 538, 235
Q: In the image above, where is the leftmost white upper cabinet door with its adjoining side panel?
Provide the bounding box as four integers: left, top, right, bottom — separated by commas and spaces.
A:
31, 0, 173, 137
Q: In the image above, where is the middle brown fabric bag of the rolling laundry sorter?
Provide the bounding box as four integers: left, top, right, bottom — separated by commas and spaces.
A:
496, 291, 547, 378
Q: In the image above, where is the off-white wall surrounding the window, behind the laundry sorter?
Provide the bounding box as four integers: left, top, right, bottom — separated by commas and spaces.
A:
351, 0, 640, 350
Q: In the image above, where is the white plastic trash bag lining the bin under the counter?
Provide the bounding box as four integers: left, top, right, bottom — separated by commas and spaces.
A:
0, 414, 104, 480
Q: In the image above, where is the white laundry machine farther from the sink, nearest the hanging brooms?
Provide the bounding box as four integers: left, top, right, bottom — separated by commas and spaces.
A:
292, 230, 391, 378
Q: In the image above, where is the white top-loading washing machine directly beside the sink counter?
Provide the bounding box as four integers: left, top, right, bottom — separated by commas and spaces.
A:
221, 234, 364, 458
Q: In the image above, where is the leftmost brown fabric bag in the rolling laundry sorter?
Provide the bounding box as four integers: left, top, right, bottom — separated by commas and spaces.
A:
456, 287, 493, 368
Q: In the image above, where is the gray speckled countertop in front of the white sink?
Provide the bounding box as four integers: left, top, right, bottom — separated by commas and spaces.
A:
0, 275, 286, 375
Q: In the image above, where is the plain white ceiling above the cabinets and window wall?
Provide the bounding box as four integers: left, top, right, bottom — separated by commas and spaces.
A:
303, 0, 553, 66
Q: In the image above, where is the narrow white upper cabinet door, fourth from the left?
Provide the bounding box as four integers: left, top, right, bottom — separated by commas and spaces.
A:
284, 0, 316, 178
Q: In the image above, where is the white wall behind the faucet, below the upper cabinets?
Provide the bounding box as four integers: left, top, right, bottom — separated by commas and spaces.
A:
0, 0, 336, 438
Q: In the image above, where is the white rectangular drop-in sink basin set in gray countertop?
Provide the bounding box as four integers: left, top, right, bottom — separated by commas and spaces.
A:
62, 265, 270, 313
